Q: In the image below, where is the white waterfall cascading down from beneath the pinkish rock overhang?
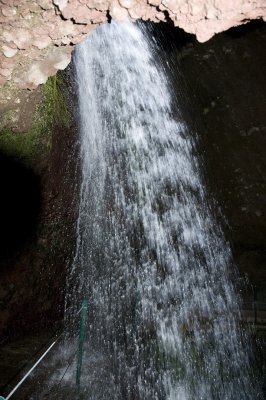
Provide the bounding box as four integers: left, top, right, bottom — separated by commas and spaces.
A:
69, 22, 259, 400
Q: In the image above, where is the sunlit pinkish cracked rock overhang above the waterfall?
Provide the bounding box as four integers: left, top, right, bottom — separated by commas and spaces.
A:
0, 0, 266, 89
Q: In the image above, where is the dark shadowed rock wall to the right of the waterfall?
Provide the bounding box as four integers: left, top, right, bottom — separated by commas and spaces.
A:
170, 23, 266, 304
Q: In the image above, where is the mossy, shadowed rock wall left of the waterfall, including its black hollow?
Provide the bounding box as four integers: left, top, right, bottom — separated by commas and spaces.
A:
0, 71, 78, 340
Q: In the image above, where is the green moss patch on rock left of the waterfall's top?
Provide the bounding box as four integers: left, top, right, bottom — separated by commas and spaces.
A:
0, 75, 69, 166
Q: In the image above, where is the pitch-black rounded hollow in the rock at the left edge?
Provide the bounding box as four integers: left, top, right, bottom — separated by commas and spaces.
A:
0, 153, 41, 260
